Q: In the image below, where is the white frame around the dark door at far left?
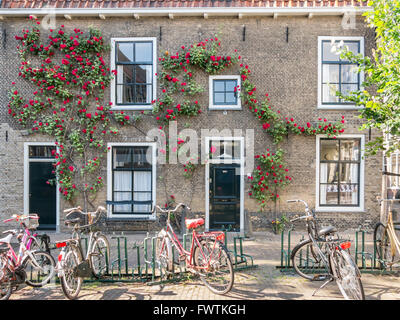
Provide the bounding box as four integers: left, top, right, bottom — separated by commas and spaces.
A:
24, 142, 60, 232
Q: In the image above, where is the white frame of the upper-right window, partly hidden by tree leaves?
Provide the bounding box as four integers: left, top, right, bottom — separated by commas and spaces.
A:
317, 36, 365, 110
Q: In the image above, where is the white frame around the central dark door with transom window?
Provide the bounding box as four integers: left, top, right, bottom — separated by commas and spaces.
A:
204, 137, 244, 235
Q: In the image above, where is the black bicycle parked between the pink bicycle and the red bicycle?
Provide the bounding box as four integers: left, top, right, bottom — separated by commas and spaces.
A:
56, 206, 110, 300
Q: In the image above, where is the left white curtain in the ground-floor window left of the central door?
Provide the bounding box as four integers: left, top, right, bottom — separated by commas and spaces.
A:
114, 171, 132, 212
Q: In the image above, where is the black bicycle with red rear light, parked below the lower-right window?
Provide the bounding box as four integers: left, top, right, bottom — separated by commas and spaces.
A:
288, 200, 365, 300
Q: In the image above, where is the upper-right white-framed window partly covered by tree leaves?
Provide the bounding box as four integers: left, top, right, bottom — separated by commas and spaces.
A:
318, 37, 364, 109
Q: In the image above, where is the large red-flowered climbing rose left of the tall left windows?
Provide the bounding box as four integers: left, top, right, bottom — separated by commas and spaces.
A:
8, 17, 137, 206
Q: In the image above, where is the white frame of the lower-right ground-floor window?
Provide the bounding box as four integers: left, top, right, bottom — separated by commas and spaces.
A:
315, 134, 365, 212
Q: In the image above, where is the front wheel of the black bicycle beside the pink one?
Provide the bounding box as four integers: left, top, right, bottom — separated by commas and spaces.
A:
90, 235, 110, 278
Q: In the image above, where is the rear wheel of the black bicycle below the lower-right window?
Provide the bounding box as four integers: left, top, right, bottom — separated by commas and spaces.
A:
330, 250, 365, 300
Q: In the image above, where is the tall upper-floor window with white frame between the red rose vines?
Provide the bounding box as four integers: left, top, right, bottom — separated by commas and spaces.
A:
111, 38, 157, 110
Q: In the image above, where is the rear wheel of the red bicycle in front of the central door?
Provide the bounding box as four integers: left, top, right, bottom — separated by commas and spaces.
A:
193, 238, 234, 294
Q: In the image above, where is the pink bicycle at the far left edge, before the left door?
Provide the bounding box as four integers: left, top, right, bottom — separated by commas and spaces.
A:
0, 214, 56, 300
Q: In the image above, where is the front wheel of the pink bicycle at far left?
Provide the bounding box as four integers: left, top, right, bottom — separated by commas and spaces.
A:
24, 251, 56, 288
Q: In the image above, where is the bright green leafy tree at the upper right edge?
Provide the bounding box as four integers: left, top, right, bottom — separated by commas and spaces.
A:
337, 0, 400, 155
